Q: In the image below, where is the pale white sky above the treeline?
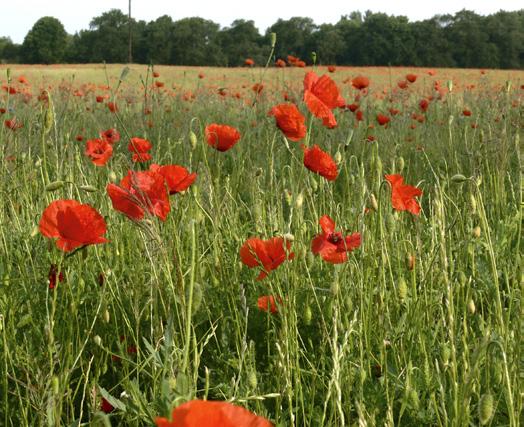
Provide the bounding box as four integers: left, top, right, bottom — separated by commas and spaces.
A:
0, 0, 524, 43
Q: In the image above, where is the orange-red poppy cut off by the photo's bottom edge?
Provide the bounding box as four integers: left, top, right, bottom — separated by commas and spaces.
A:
155, 400, 273, 427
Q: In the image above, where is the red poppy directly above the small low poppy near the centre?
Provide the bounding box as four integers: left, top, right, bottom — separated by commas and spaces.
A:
240, 237, 295, 280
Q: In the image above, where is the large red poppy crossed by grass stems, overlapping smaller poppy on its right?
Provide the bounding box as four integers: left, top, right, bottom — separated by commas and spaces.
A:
106, 171, 170, 221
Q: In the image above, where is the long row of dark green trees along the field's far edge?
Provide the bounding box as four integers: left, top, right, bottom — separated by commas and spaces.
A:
0, 9, 524, 69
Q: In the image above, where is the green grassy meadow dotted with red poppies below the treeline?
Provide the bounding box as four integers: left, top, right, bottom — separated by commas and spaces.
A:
0, 61, 524, 427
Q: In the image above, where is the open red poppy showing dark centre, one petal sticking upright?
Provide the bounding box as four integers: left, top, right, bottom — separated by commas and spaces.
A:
311, 215, 362, 264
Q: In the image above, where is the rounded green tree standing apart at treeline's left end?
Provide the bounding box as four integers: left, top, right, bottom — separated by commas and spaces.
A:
21, 16, 67, 64
